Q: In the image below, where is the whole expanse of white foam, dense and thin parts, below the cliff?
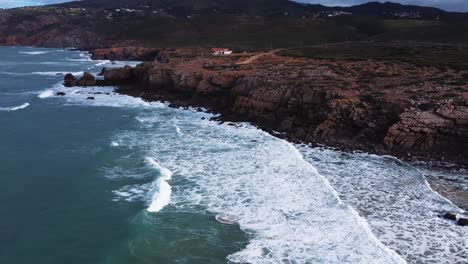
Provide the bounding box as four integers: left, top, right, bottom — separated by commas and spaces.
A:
89, 88, 468, 263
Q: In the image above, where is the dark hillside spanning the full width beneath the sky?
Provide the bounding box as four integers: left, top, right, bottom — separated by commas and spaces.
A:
0, 0, 468, 51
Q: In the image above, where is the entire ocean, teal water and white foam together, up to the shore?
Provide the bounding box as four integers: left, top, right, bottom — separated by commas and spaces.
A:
0, 47, 468, 264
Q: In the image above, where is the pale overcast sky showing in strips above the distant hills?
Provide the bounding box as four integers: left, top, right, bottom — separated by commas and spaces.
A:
0, 0, 468, 12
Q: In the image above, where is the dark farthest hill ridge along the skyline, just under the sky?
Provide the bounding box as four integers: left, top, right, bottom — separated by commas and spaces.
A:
56, 0, 460, 19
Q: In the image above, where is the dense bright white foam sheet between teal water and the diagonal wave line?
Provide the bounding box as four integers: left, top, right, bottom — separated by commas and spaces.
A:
109, 112, 404, 263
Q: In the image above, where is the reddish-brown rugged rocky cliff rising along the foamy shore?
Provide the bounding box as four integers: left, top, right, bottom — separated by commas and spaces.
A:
68, 53, 468, 164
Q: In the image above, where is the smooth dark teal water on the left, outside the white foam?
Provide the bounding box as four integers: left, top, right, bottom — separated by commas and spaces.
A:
0, 48, 246, 263
